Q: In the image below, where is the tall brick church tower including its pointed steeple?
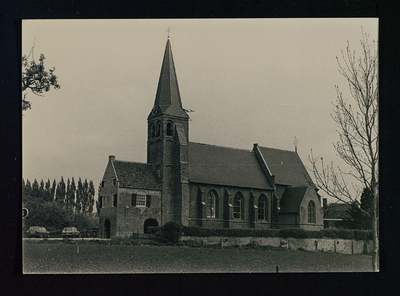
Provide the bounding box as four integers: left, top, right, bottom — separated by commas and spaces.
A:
147, 39, 189, 225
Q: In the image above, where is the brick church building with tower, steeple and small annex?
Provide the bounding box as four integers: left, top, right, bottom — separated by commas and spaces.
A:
99, 39, 323, 238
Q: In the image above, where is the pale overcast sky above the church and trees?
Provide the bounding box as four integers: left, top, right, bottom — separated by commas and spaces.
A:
22, 18, 378, 202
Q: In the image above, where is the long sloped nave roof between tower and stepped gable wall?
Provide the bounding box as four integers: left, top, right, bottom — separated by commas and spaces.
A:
189, 142, 272, 189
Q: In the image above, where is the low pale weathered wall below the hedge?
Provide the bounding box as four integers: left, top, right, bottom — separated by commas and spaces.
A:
180, 236, 372, 254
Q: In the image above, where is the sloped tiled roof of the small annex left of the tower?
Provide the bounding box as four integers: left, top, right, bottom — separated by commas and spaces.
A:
113, 160, 161, 190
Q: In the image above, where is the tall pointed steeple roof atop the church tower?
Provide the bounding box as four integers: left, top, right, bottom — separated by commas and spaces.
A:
148, 39, 189, 119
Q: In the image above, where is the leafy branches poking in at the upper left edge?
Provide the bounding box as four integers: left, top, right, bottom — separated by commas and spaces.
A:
22, 41, 61, 111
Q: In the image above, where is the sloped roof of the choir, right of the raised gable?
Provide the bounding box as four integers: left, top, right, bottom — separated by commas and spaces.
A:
259, 146, 313, 186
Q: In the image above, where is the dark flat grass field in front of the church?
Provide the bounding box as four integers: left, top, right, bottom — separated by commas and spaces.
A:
23, 241, 372, 274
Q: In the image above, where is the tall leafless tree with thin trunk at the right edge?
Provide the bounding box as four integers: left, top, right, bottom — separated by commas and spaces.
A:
309, 32, 379, 271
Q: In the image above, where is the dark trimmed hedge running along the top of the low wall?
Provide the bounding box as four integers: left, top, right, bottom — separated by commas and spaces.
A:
182, 226, 372, 240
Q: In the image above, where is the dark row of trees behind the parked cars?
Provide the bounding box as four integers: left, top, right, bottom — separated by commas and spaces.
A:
22, 177, 98, 229
